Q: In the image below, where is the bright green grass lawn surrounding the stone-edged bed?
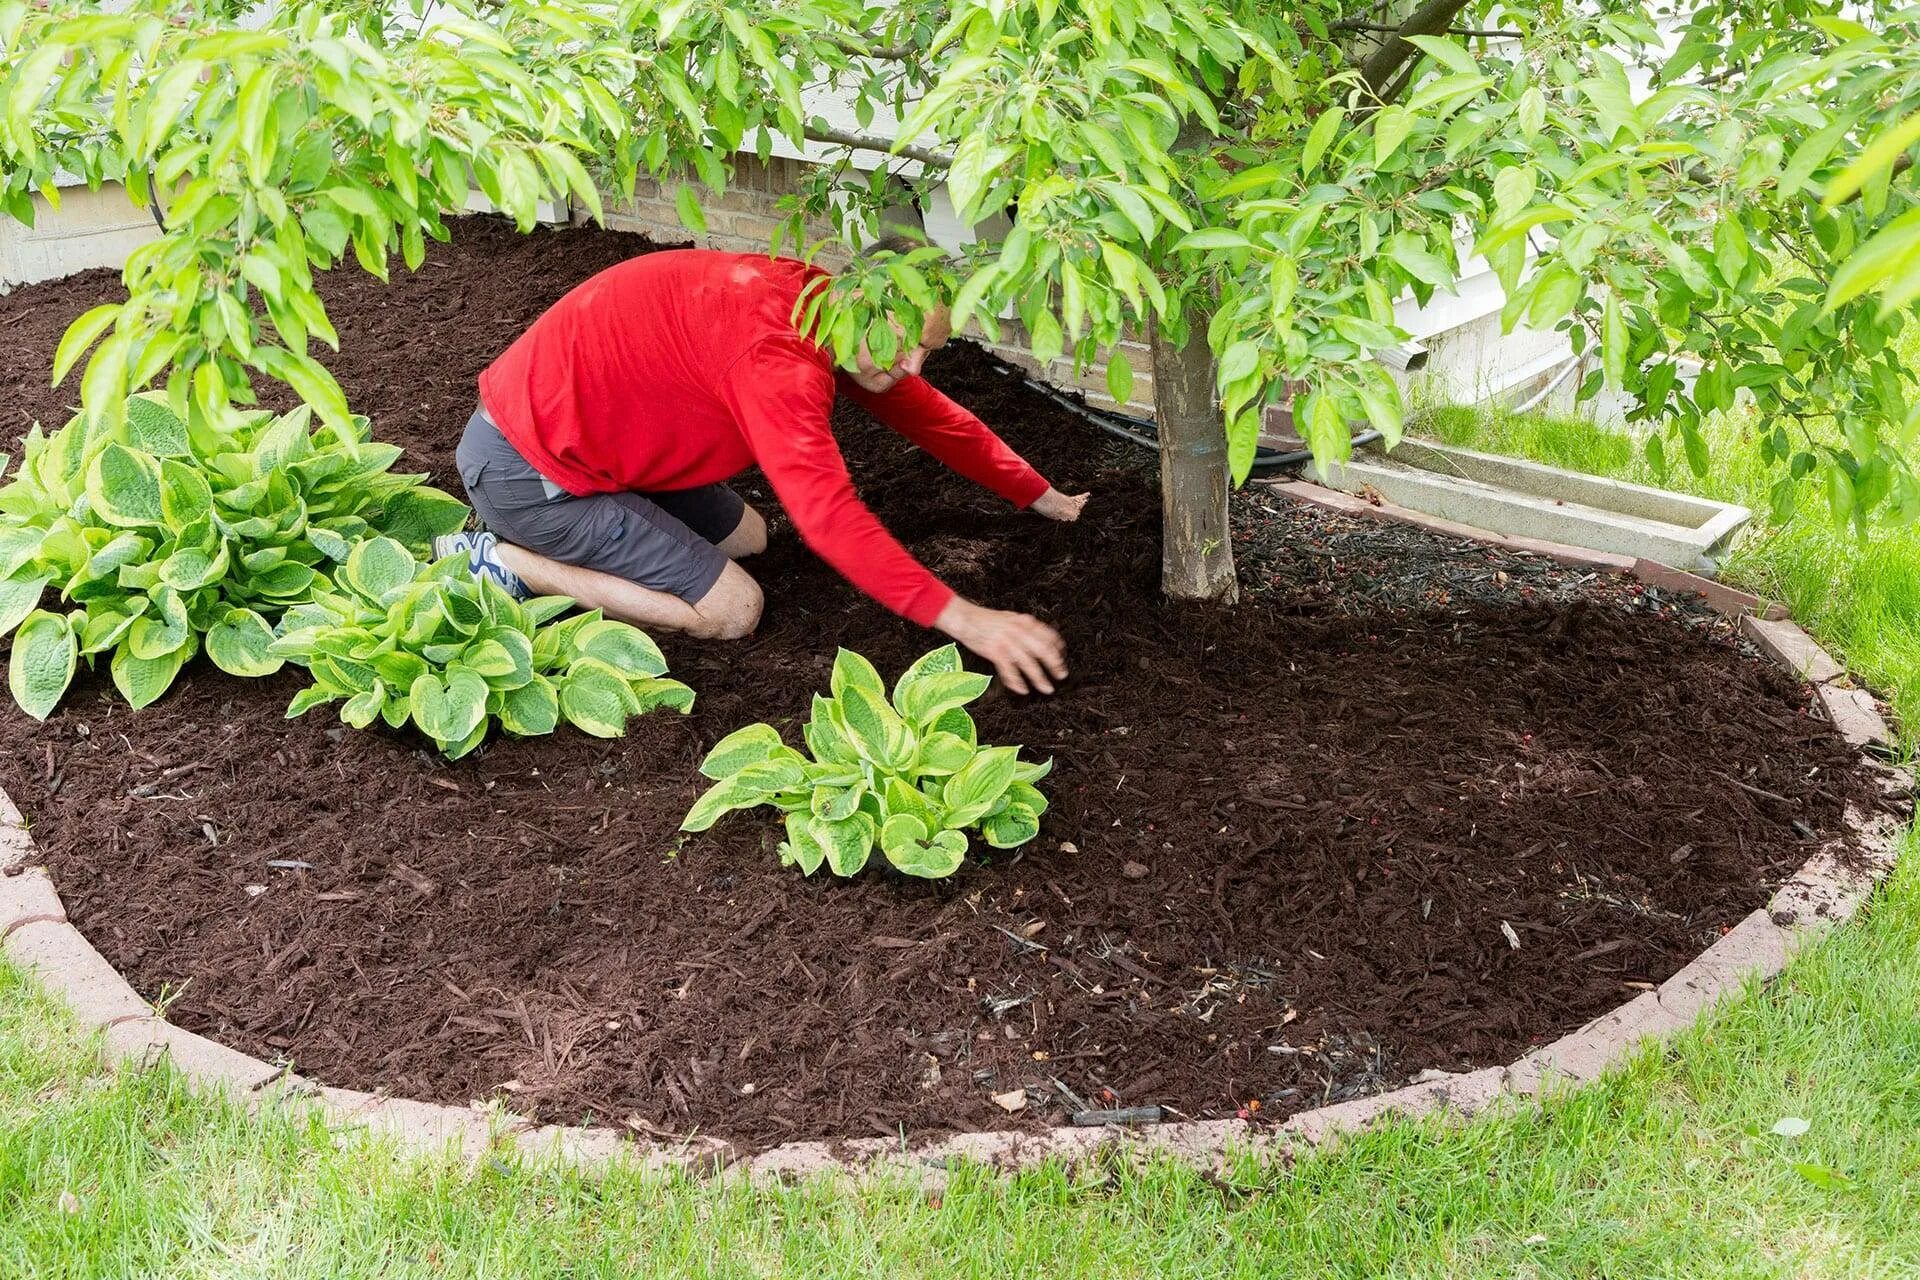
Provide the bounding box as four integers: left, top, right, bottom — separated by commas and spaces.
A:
0, 397, 1920, 1278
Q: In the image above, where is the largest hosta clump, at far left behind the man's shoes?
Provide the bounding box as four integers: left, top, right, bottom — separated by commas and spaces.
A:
0, 393, 467, 720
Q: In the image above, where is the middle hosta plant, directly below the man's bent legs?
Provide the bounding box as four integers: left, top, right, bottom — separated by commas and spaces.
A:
269, 537, 693, 760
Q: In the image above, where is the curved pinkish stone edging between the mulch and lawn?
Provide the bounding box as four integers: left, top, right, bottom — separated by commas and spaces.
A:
0, 614, 1912, 1180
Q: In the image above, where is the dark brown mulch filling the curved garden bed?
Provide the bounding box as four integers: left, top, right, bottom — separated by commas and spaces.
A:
0, 221, 1859, 1146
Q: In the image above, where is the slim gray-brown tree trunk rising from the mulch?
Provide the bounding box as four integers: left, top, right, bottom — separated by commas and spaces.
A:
1154, 322, 1240, 604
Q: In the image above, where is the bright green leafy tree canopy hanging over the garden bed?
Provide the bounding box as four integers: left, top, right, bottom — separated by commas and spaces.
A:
0, 0, 1920, 526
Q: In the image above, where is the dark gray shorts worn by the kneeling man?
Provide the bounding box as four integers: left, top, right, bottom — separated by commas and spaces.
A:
453, 409, 747, 604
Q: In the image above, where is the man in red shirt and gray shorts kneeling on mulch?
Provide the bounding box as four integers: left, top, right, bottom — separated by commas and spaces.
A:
436, 249, 1087, 693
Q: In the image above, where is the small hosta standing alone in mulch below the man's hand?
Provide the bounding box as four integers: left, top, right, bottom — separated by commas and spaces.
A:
680, 645, 1052, 879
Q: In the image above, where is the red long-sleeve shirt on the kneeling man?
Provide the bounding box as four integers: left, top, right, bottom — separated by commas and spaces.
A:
480, 249, 1046, 626
